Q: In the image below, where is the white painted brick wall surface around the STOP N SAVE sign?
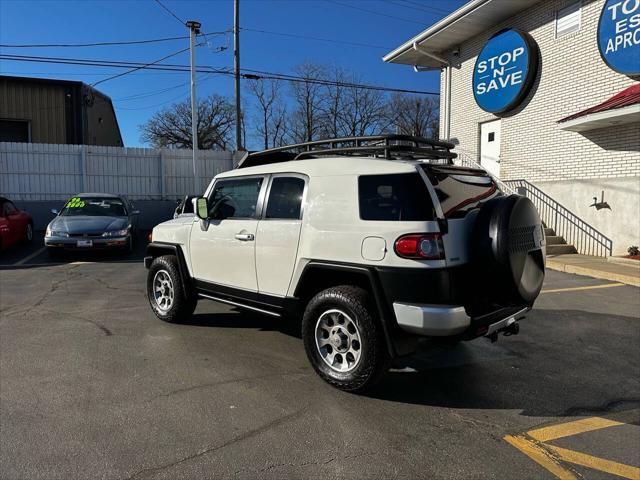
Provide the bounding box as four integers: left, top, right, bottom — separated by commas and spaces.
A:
441, 0, 640, 184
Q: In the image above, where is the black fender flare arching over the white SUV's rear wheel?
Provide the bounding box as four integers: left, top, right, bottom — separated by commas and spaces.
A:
294, 260, 398, 357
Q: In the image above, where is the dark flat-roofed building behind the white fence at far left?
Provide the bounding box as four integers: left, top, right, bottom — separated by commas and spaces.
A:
0, 76, 124, 147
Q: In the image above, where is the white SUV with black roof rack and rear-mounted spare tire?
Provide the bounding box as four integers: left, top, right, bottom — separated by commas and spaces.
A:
145, 135, 545, 391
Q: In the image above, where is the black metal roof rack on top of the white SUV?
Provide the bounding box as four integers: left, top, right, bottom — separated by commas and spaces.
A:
237, 134, 458, 168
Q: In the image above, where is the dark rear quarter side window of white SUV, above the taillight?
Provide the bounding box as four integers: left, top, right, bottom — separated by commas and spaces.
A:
358, 172, 435, 222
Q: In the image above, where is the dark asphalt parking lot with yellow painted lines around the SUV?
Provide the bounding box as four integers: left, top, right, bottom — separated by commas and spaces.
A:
0, 242, 640, 479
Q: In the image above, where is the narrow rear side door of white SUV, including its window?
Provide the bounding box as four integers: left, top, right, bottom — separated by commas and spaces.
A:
256, 174, 308, 296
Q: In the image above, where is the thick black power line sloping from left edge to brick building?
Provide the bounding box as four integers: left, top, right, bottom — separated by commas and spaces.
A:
0, 55, 439, 95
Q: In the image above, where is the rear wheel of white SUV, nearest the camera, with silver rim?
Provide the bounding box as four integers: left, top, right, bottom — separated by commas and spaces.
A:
302, 286, 390, 392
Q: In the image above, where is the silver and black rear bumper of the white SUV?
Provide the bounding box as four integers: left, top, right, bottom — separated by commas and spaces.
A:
393, 302, 530, 338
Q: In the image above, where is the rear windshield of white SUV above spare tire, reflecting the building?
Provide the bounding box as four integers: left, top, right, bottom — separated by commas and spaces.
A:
423, 166, 502, 218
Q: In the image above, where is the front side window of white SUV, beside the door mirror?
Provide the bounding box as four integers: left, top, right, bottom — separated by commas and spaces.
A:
209, 177, 264, 220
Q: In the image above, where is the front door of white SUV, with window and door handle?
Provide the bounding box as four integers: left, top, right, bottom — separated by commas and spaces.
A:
190, 176, 266, 292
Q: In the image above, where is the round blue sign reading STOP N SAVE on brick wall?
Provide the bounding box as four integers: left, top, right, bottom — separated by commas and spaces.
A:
473, 29, 536, 113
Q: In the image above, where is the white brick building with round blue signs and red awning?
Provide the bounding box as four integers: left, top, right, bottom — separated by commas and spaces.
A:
384, 0, 640, 255
